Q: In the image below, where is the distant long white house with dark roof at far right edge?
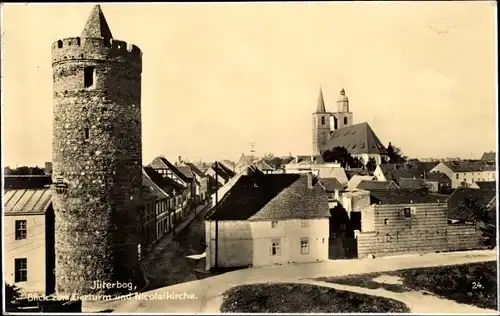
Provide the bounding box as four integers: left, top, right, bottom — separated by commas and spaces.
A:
431, 162, 496, 188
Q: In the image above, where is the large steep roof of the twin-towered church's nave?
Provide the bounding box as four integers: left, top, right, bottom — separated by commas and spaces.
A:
322, 122, 387, 154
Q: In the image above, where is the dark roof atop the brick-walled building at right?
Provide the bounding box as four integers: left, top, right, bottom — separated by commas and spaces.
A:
370, 189, 449, 204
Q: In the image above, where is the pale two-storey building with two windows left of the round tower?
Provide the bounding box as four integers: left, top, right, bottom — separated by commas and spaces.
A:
3, 188, 55, 295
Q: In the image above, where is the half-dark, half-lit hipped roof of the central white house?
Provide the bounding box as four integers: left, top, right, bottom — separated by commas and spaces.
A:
206, 173, 330, 220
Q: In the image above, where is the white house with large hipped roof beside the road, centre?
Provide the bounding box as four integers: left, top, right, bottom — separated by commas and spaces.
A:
205, 173, 330, 270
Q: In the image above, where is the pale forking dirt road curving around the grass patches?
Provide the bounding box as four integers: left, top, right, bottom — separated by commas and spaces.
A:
105, 250, 497, 313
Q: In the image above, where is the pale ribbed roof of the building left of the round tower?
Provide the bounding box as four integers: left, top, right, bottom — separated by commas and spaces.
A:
3, 188, 52, 215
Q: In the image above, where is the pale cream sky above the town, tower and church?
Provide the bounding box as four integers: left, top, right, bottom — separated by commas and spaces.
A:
1, 1, 497, 166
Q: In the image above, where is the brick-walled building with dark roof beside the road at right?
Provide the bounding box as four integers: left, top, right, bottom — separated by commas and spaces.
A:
356, 190, 480, 258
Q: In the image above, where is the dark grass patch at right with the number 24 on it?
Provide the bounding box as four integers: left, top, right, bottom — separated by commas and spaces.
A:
320, 261, 497, 310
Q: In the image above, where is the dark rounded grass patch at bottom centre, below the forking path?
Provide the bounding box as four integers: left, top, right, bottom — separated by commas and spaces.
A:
221, 284, 410, 313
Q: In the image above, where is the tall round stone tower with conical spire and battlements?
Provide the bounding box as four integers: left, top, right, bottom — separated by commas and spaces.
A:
52, 5, 143, 295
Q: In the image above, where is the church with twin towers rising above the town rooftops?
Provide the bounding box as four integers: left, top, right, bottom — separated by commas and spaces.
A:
312, 88, 387, 164
